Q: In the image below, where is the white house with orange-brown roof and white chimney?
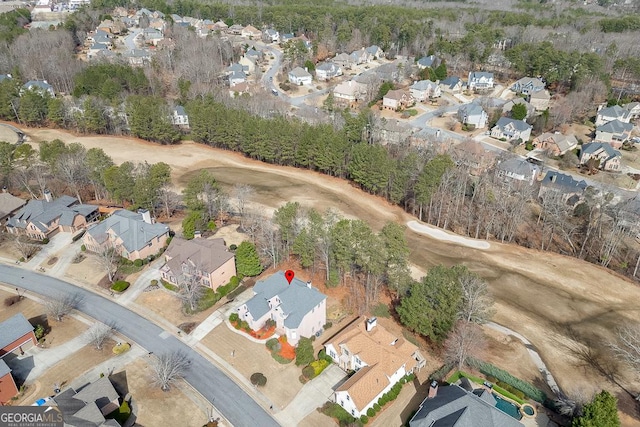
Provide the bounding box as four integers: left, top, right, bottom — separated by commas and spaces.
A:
324, 317, 426, 418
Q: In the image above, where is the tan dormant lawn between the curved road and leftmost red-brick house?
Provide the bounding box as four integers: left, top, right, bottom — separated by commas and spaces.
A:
0, 291, 87, 348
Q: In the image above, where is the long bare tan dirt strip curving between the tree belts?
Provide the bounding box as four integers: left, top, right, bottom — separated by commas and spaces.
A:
20, 129, 640, 422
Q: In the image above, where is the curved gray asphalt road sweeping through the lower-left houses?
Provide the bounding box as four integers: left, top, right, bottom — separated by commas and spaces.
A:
0, 265, 279, 427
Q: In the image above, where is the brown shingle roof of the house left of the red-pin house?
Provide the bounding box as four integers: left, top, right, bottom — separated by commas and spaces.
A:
165, 237, 233, 274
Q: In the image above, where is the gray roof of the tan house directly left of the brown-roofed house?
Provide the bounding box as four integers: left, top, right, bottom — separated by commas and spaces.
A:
87, 210, 169, 252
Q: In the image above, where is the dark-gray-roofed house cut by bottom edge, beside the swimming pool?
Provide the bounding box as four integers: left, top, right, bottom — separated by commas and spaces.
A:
409, 381, 523, 427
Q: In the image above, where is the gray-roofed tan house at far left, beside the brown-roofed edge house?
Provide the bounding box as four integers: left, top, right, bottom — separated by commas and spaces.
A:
7, 191, 99, 240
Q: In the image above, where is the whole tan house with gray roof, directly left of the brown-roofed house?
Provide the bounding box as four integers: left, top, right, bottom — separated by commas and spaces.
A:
82, 209, 169, 261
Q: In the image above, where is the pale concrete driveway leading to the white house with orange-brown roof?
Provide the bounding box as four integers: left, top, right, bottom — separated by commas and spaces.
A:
275, 365, 347, 427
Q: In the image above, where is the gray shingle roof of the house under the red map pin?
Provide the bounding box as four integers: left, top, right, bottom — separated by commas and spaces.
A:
246, 271, 327, 329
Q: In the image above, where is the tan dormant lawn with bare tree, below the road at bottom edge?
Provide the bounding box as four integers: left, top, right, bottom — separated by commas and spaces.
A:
125, 359, 206, 427
